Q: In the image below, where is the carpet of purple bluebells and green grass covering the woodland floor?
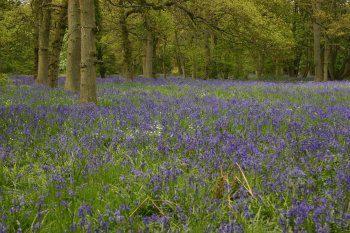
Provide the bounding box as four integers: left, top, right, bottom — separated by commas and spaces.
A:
0, 77, 350, 232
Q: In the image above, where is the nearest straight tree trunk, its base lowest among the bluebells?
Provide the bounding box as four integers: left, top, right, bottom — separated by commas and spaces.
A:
79, 0, 97, 103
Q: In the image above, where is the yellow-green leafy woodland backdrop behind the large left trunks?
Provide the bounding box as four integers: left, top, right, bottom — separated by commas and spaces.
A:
0, 0, 350, 83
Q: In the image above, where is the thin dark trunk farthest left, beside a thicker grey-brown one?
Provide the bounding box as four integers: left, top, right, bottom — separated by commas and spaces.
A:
31, 0, 42, 79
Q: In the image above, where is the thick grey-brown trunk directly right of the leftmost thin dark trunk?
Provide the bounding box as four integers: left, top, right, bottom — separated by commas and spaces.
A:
36, 0, 52, 84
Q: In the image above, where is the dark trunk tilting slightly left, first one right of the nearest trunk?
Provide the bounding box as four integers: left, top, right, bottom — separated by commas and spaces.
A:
119, 12, 134, 80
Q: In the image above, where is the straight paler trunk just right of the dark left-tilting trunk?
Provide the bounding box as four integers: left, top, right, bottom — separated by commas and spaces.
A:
143, 28, 154, 78
